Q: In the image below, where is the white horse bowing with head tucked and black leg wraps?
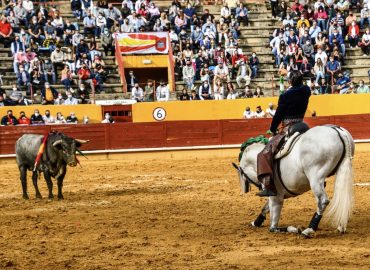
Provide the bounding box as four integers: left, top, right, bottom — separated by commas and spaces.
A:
234, 126, 354, 237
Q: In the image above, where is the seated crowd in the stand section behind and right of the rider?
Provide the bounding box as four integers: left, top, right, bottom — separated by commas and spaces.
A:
270, 0, 370, 94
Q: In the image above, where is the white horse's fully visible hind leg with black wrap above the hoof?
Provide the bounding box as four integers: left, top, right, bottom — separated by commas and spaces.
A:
302, 178, 329, 237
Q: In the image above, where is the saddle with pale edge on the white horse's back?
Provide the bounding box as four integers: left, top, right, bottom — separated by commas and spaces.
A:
274, 122, 310, 160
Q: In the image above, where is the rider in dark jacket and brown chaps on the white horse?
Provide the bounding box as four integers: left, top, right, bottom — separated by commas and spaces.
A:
257, 71, 311, 197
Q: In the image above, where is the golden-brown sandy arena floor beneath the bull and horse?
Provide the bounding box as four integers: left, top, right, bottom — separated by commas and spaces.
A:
0, 152, 370, 269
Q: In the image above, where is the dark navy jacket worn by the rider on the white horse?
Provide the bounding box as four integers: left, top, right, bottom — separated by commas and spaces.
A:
270, 85, 311, 133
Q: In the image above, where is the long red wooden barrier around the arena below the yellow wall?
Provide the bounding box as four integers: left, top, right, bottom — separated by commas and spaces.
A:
0, 114, 370, 154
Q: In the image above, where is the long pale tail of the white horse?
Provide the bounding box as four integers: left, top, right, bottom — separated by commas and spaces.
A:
326, 128, 354, 232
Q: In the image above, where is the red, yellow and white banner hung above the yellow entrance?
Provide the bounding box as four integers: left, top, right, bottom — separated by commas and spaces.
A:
116, 32, 169, 54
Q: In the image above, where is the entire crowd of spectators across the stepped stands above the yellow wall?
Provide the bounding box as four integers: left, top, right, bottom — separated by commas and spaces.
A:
0, 0, 370, 105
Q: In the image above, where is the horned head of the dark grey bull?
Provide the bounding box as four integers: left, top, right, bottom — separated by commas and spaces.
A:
53, 136, 89, 167
